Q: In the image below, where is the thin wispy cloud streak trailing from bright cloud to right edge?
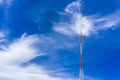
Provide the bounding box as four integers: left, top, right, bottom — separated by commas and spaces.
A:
93, 10, 120, 30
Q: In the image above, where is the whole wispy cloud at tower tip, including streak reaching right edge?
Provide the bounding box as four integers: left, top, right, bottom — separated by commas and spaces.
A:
53, 1, 120, 36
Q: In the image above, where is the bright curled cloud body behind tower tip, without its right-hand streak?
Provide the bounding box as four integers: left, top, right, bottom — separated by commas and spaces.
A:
53, 1, 93, 36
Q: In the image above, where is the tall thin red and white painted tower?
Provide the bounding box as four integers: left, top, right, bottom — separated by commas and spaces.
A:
79, 29, 84, 80
